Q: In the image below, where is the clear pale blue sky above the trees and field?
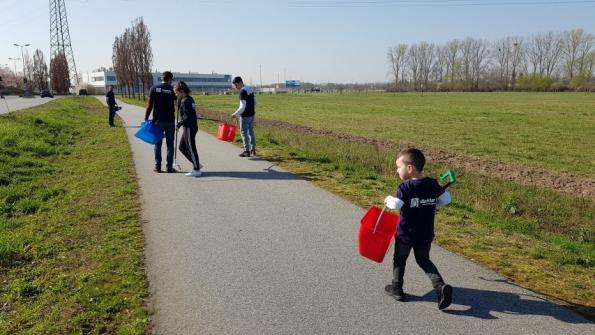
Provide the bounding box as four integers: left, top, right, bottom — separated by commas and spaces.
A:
0, 0, 595, 84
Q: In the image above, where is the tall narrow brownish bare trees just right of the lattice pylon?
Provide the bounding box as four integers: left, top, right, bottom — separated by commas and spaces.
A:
112, 17, 153, 99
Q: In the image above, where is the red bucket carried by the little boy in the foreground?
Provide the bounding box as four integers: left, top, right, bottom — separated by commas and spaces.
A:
359, 207, 399, 263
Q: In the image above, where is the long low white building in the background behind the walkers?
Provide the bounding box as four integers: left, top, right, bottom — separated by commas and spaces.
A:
82, 69, 231, 94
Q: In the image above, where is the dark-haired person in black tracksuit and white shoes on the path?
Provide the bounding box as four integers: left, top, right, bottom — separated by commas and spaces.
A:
174, 81, 202, 177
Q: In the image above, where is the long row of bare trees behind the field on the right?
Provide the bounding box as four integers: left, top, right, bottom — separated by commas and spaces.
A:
387, 29, 595, 91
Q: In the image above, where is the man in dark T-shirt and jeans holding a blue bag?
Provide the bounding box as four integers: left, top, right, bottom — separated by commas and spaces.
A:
145, 71, 176, 173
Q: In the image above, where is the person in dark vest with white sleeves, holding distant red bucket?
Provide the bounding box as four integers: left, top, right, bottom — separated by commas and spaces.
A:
231, 77, 256, 157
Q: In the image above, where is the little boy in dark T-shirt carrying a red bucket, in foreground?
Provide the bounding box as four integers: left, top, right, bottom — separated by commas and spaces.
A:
384, 149, 452, 310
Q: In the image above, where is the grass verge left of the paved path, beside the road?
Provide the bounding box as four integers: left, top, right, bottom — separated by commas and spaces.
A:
0, 97, 149, 335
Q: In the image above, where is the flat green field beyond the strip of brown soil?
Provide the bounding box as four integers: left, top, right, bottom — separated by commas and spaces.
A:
195, 93, 595, 177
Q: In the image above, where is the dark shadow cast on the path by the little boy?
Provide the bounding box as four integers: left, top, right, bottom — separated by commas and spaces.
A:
408, 280, 590, 324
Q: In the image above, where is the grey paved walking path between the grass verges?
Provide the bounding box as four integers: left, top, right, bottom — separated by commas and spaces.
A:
100, 98, 595, 335
